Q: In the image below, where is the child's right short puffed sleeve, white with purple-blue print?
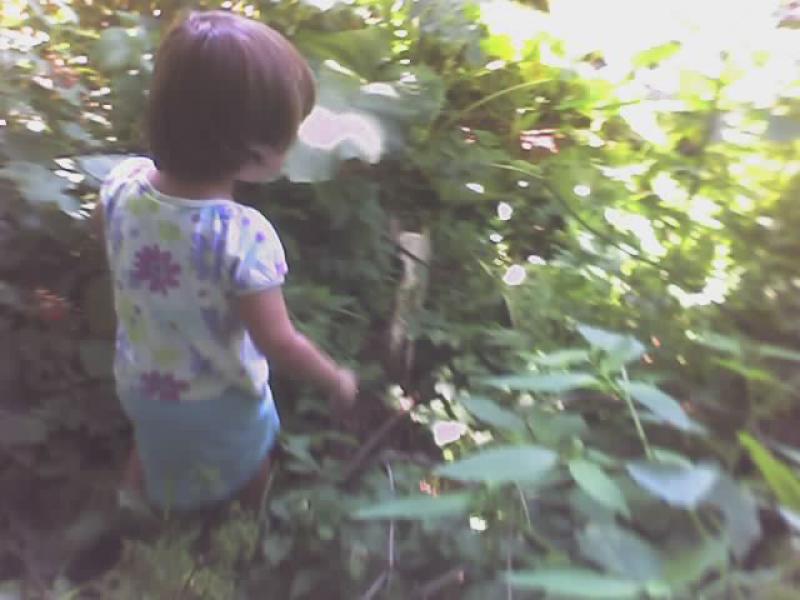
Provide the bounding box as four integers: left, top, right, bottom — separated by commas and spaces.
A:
229, 208, 289, 295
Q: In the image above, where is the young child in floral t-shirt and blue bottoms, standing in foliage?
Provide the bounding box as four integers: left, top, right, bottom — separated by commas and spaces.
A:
99, 12, 357, 509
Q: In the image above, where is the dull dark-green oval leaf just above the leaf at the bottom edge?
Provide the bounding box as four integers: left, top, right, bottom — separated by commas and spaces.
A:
578, 523, 662, 582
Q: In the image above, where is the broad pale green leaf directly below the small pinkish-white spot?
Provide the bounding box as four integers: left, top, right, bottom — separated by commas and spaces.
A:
435, 446, 557, 483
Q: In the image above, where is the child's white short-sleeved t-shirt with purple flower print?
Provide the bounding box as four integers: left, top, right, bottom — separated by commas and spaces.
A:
100, 158, 287, 403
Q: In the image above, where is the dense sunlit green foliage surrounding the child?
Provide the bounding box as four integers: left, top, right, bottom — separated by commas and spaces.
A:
0, 0, 800, 600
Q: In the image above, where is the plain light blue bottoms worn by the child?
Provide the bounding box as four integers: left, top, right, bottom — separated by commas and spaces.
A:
119, 386, 280, 510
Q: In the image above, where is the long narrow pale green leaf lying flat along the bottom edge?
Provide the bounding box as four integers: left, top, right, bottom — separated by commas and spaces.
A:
506, 568, 642, 600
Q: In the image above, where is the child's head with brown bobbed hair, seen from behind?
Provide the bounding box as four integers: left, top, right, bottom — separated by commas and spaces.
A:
148, 11, 315, 181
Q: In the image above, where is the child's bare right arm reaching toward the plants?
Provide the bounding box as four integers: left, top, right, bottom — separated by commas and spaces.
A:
238, 287, 358, 409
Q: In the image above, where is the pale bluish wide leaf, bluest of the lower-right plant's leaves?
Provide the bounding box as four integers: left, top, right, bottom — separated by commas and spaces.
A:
627, 461, 719, 509
